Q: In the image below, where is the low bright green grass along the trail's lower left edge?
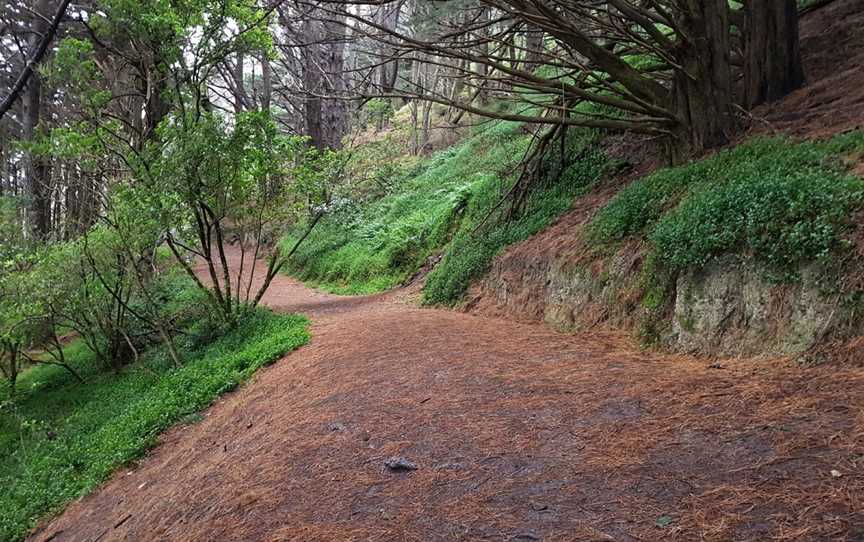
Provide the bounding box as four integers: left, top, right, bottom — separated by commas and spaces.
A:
0, 310, 309, 540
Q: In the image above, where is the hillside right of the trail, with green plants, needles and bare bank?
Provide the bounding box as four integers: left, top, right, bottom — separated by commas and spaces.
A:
286, 0, 864, 359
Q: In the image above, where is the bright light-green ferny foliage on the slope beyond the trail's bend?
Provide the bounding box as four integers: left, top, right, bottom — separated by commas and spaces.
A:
282, 115, 530, 294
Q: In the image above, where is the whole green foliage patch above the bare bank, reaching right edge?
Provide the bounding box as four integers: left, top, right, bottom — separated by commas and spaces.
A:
590, 132, 864, 279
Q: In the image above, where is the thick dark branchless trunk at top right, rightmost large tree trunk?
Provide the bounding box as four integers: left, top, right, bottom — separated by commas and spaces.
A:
744, 0, 804, 109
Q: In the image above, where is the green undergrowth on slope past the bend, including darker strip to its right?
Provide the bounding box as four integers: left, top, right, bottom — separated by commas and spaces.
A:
282, 115, 605, 304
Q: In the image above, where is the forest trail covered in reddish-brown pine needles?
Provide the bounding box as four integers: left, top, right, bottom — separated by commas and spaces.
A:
32, 249, 864, 541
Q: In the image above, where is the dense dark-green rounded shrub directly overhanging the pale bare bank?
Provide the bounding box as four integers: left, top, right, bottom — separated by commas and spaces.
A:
649, 171, 864, 271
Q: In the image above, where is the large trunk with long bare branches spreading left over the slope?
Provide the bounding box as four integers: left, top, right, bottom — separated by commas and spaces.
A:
670, 0, 735, 162
